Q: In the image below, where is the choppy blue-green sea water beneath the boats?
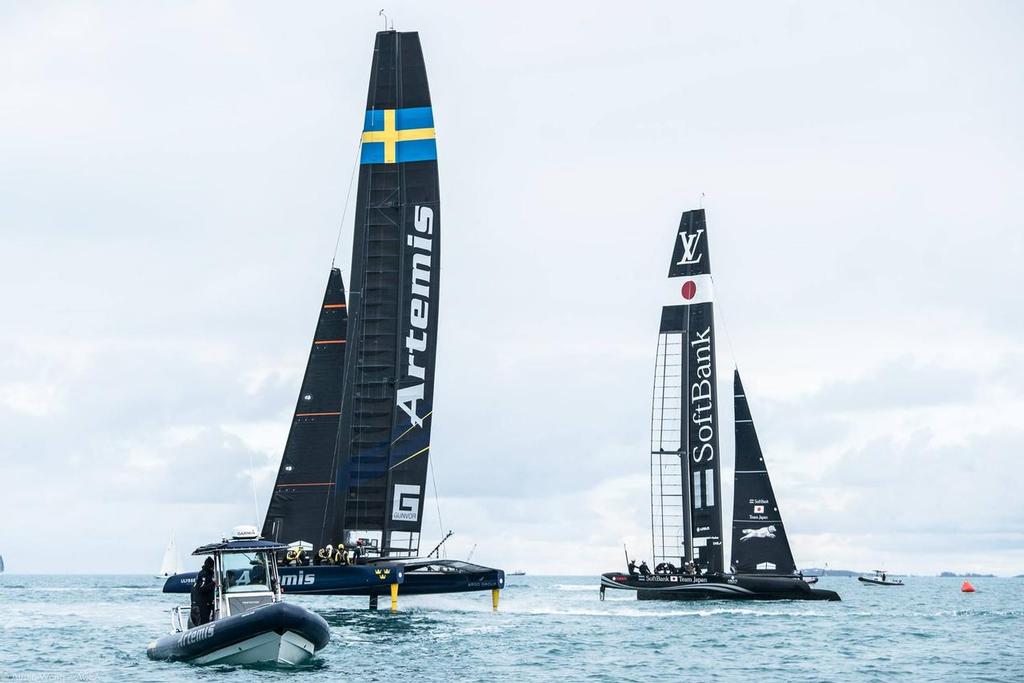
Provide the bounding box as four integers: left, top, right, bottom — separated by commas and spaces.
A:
0, 574, 1024, 683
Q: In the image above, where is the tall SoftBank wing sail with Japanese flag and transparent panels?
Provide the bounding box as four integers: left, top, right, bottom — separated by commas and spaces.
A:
651, 209, 723, 571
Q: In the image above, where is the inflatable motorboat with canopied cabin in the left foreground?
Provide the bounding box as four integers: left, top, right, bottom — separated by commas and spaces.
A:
146, 526, 331, 665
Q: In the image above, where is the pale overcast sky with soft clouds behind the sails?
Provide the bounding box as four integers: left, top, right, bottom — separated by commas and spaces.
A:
0, 1, 1024, 574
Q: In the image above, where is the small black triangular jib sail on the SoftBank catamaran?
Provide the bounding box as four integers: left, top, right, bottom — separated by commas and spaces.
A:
732, 371, 797, 573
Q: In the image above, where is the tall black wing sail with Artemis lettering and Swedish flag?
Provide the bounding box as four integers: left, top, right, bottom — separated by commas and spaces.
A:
334, 31, 440, 555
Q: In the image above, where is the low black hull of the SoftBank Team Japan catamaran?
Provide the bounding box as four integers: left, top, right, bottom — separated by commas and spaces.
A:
601, 571, 840, 601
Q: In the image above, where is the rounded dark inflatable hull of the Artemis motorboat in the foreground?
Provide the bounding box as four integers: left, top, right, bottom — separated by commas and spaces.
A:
146, 602, 331, 665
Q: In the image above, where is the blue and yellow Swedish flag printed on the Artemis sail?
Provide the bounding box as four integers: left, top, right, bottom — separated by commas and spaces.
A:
359, 106, 437, 164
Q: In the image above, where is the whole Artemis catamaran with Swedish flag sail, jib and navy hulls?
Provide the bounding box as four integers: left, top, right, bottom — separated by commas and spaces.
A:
164, 31, 505, 606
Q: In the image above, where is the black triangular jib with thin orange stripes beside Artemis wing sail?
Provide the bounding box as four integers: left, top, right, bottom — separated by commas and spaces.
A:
263, 268, 348, 548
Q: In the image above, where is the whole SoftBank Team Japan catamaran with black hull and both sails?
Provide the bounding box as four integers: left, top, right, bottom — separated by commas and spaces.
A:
601, 210, 840, 600
